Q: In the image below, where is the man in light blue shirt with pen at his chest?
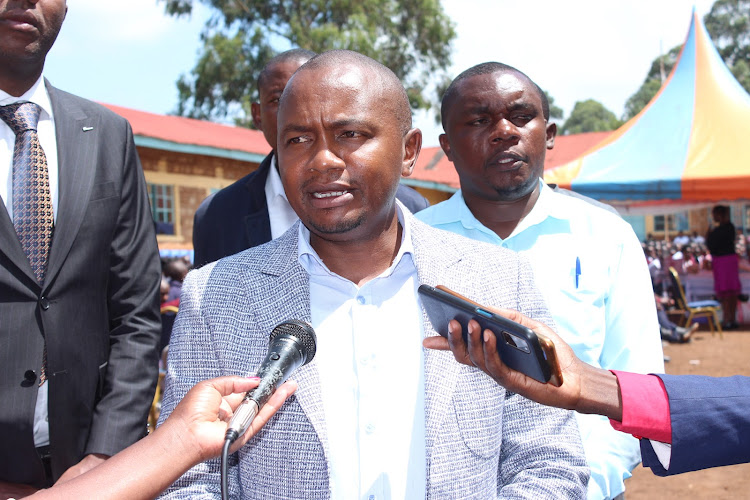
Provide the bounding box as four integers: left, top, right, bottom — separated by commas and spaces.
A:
418, 63, 664, 499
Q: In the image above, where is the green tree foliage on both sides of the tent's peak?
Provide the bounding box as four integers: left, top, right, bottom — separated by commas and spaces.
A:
623, 0, 750, 120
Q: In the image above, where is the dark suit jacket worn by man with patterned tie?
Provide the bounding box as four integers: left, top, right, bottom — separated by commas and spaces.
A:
0, 85, 161, 484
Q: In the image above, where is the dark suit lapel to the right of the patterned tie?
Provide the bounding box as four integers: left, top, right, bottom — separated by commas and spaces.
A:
45, 84, 100, 283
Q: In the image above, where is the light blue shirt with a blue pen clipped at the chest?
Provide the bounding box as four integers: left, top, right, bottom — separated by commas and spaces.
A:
415, 180, 664, 499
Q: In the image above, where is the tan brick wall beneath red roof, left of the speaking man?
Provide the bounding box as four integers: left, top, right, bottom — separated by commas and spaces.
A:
137, 147, 259, 250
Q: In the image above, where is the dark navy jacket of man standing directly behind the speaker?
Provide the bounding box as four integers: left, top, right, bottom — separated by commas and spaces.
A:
193, 152, 430, 266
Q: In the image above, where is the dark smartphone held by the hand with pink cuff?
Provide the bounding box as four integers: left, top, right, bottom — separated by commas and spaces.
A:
418, 285, 562, 387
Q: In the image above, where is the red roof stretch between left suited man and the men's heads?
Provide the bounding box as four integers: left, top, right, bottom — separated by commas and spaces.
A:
104, 104, 271, 155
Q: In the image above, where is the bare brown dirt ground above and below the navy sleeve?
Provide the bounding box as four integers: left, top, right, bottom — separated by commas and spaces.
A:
625, 325, 750, 500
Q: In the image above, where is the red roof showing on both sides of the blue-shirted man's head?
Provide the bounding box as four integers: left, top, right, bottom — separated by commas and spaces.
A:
411, 132, 612, 189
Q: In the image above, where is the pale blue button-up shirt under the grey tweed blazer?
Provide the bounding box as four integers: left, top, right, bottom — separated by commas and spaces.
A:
299, 204, 426, 500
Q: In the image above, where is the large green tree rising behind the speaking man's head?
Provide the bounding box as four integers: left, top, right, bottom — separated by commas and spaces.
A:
158, 0, 456, 126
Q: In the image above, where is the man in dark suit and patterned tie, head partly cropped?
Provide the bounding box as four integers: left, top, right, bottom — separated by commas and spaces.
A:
0, 0, 160, 492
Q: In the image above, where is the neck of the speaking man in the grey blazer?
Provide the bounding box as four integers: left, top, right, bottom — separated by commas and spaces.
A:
310, 212, 403, 286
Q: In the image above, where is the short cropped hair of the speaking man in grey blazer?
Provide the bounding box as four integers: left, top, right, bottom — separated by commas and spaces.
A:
297, 50, 412, 135
